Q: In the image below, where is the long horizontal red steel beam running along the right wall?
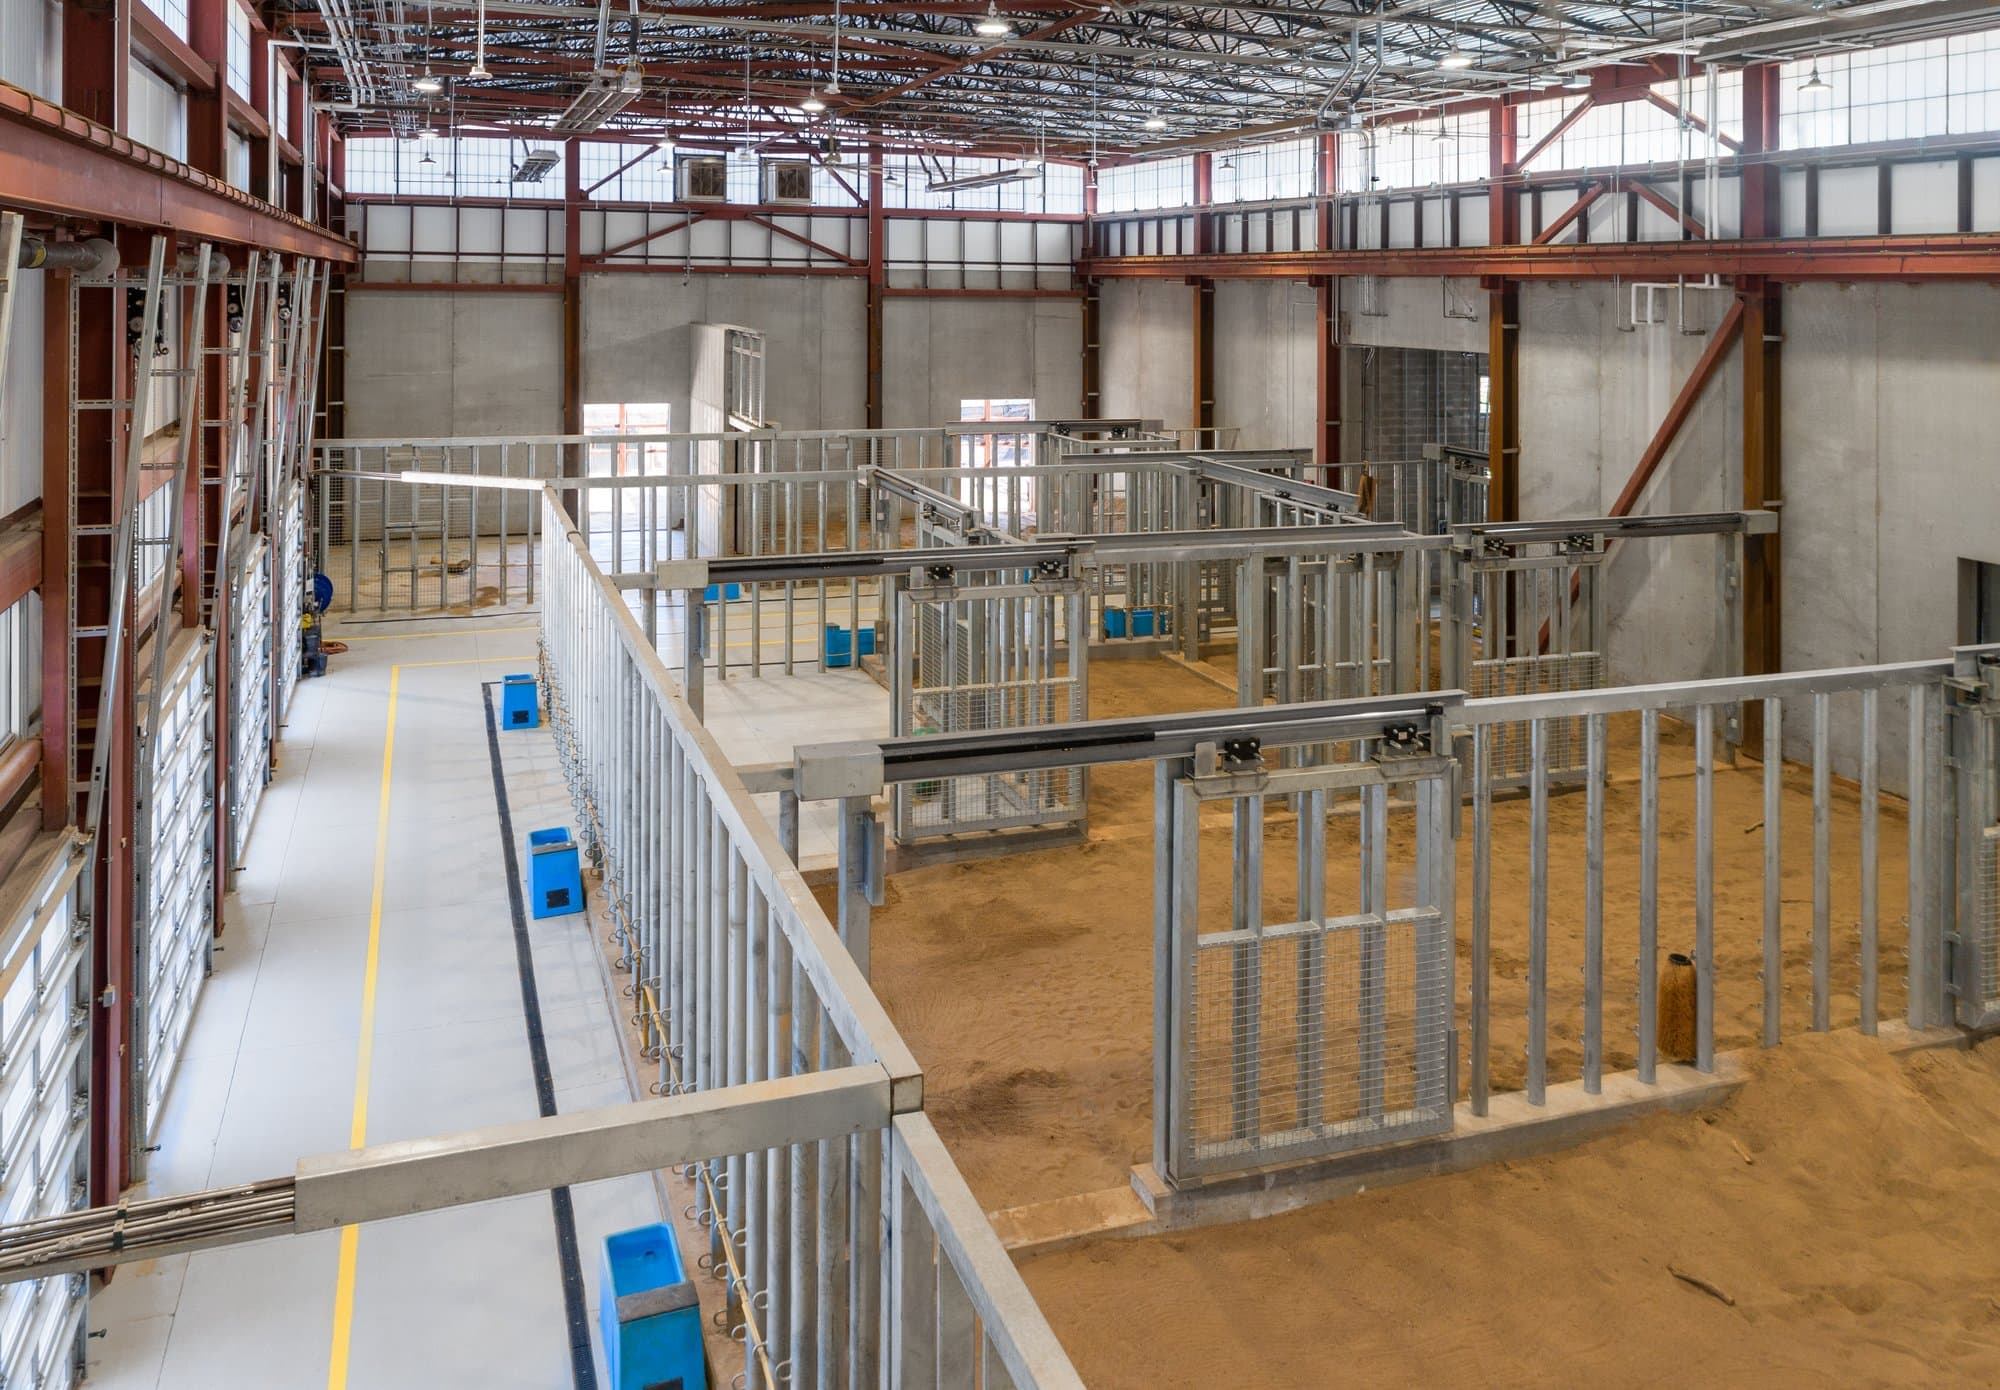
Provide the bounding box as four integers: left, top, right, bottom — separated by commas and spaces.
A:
1080, 232, 2000, 282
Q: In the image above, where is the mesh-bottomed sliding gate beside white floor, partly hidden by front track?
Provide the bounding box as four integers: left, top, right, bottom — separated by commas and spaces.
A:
896, 582, 1088, 844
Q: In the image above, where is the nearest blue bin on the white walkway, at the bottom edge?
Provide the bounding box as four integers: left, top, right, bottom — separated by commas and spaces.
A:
598, 1226, 708, 1390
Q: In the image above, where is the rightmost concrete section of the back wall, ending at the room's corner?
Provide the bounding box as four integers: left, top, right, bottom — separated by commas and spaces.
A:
882, 296, 1084, 430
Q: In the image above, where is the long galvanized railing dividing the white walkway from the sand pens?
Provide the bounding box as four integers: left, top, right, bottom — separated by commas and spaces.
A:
542, 492, 1080, 1390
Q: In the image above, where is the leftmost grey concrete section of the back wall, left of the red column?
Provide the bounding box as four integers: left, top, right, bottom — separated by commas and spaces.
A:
346, 290, 562, 438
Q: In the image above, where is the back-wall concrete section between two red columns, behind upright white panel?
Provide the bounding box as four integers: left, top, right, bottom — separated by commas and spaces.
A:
576, 274, 864, 430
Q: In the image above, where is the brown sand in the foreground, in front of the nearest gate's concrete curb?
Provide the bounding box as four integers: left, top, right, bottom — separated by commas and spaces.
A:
1022, 1032, 2000, 1390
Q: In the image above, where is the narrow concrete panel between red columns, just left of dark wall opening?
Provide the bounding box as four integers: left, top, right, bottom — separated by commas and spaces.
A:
1216, 280, 1318, 448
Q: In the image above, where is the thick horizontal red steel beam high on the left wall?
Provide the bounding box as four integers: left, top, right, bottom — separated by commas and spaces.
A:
0, 82, 358, 264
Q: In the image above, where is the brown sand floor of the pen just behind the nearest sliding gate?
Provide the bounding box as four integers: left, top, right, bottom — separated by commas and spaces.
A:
852, 660, 1906, 1208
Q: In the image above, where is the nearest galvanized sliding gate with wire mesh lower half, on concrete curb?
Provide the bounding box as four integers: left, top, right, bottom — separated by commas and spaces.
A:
1154, 746, 1456, 1180
